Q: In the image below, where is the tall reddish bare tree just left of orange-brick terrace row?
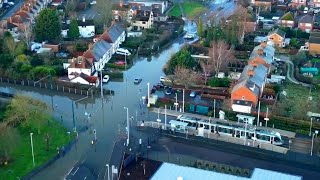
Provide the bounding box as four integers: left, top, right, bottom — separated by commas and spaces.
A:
209, 40, 234, 76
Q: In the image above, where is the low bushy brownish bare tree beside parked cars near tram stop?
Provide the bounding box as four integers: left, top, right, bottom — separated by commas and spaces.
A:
174, 66, 198, 89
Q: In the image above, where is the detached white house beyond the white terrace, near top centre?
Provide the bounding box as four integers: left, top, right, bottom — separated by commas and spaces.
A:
131, 11, 154, 30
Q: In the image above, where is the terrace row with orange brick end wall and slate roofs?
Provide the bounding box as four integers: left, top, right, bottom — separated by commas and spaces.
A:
231, 42, 275, 113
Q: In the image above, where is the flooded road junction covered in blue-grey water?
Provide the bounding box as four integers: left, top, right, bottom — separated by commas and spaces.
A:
0, 20, 196, 179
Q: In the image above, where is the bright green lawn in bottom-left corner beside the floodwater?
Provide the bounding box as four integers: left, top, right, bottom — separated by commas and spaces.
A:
0, 120, 73, 180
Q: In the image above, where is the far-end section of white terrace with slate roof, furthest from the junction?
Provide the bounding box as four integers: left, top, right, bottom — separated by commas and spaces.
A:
98, 23, 126, 54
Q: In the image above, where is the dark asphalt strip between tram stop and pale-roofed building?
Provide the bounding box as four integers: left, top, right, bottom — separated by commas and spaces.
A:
148, 137, 320, 179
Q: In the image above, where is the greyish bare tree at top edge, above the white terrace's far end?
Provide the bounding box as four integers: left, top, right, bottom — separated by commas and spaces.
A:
95, 0, 112, 29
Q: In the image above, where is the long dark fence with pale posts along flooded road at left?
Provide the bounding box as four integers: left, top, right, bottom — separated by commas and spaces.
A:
0, 77, 94, 96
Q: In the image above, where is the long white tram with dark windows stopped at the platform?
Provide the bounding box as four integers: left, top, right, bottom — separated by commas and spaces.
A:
177, 115, 283, 145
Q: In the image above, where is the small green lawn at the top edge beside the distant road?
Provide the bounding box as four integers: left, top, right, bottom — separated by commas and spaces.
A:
182, 2, 207, 19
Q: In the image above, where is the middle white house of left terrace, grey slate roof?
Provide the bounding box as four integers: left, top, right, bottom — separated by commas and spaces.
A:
92, 39, 112, 71
